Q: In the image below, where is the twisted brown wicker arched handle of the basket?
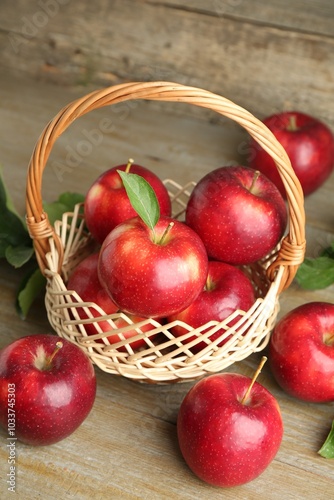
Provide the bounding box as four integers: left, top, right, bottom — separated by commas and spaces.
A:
26, 82, 305, 291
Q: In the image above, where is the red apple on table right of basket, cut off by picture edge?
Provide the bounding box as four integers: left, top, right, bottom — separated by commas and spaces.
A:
268, 302, 334, 403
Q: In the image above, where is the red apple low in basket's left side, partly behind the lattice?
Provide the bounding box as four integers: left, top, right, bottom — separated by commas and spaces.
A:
67, 252, 159, 351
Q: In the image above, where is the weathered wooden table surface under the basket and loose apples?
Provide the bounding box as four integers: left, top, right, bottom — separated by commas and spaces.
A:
0, 71, 334, 500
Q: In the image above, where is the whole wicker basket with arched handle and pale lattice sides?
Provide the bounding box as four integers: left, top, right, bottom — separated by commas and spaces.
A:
26, 82, 305, 383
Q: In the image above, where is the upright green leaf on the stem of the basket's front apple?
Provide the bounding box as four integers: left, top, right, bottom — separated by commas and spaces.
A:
117, 170, 160, 230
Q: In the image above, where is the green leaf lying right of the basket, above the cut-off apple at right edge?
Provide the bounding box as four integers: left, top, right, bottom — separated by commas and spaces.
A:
296, 256, 334, 290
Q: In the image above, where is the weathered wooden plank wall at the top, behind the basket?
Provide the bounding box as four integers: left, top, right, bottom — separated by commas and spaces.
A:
0, 0, 334, 127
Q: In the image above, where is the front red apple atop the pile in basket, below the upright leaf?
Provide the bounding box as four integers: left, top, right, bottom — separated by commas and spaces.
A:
98, 217, 208, 318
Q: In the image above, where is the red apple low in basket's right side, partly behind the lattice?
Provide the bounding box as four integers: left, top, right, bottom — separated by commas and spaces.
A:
168, 261, 255, 352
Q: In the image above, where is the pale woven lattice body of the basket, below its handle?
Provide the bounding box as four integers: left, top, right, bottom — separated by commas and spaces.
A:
46, 188, 283, 383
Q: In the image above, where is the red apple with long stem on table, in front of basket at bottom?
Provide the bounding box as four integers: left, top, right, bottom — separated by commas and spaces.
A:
177, 362, 283, 487
